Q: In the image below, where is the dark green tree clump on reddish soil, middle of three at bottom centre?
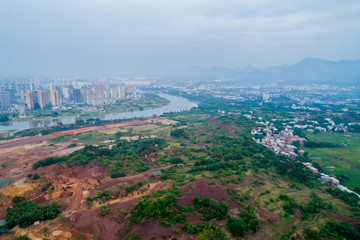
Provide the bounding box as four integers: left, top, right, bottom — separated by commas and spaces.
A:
194, 197, 229, 220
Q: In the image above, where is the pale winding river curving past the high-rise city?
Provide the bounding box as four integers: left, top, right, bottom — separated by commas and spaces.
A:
0, 93, 197, 131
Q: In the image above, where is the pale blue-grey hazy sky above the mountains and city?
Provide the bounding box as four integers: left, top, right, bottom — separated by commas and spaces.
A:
0, 0, 360, 76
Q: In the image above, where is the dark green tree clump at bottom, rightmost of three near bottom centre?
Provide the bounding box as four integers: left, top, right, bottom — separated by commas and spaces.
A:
227, 206, 260, 237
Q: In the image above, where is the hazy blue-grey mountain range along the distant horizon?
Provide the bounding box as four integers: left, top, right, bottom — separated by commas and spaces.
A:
167, 58, 360, 86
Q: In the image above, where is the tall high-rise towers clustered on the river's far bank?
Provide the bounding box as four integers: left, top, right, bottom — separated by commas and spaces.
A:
25, 84, 136, 109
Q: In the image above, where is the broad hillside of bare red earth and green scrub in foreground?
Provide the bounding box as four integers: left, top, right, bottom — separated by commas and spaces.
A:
1, 96, 360, 240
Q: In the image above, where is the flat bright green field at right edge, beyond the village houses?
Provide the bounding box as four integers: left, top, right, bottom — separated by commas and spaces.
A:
302, 133, 360, 188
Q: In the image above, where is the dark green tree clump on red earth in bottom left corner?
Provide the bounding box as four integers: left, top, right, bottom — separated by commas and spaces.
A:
5, 197, 60, 229
